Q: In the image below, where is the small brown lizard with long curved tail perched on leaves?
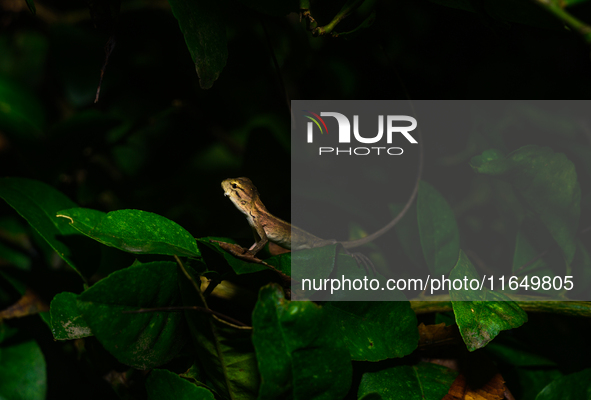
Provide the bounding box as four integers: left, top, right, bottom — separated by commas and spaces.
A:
222, 132, 423, 261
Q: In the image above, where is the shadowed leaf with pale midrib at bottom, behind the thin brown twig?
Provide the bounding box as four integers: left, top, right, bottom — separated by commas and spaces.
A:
179, 272, 260, 400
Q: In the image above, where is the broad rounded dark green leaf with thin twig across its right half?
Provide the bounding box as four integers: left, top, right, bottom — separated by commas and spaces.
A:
78, 261, 187, 369
